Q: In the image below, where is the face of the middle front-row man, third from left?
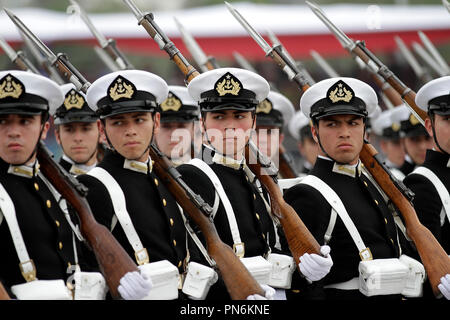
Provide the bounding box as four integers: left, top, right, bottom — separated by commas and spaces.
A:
203, 110, 254, 159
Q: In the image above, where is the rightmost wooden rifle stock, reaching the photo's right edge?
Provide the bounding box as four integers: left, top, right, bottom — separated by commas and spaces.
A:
359, 143, 450, 296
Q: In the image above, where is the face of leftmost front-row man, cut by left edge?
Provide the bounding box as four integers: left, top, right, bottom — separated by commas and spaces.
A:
0, 114, 49, 165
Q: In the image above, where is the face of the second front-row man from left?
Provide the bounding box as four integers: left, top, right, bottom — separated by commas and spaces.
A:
103, 112, 160, 162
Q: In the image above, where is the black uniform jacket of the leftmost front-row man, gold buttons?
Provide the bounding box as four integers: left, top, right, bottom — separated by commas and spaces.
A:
0, 159, 83, 288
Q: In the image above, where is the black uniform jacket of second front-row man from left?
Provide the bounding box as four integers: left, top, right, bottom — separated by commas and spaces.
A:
77, 151, 186, 272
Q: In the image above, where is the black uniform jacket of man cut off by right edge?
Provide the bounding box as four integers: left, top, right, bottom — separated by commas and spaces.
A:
404, 150, 450, 253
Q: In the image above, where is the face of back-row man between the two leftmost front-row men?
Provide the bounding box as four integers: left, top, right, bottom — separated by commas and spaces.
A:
55, 120, 100, 165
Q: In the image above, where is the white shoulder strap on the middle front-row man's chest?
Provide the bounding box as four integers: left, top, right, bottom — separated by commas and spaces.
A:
189, 158, 245, 257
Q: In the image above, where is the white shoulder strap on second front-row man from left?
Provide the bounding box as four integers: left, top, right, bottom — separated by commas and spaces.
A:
87, 167, 149, 265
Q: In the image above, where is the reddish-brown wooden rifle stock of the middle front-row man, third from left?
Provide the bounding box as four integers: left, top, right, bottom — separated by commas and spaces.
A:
246, 142, 320, 265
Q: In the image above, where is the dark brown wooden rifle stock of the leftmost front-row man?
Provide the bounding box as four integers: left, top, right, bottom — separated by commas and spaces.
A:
37, 141, 138, 298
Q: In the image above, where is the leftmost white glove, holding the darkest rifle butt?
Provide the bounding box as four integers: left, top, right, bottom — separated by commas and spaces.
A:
117, 271, 153, 300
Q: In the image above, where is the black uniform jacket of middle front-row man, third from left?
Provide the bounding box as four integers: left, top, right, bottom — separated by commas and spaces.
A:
177, 148, 275, 299
